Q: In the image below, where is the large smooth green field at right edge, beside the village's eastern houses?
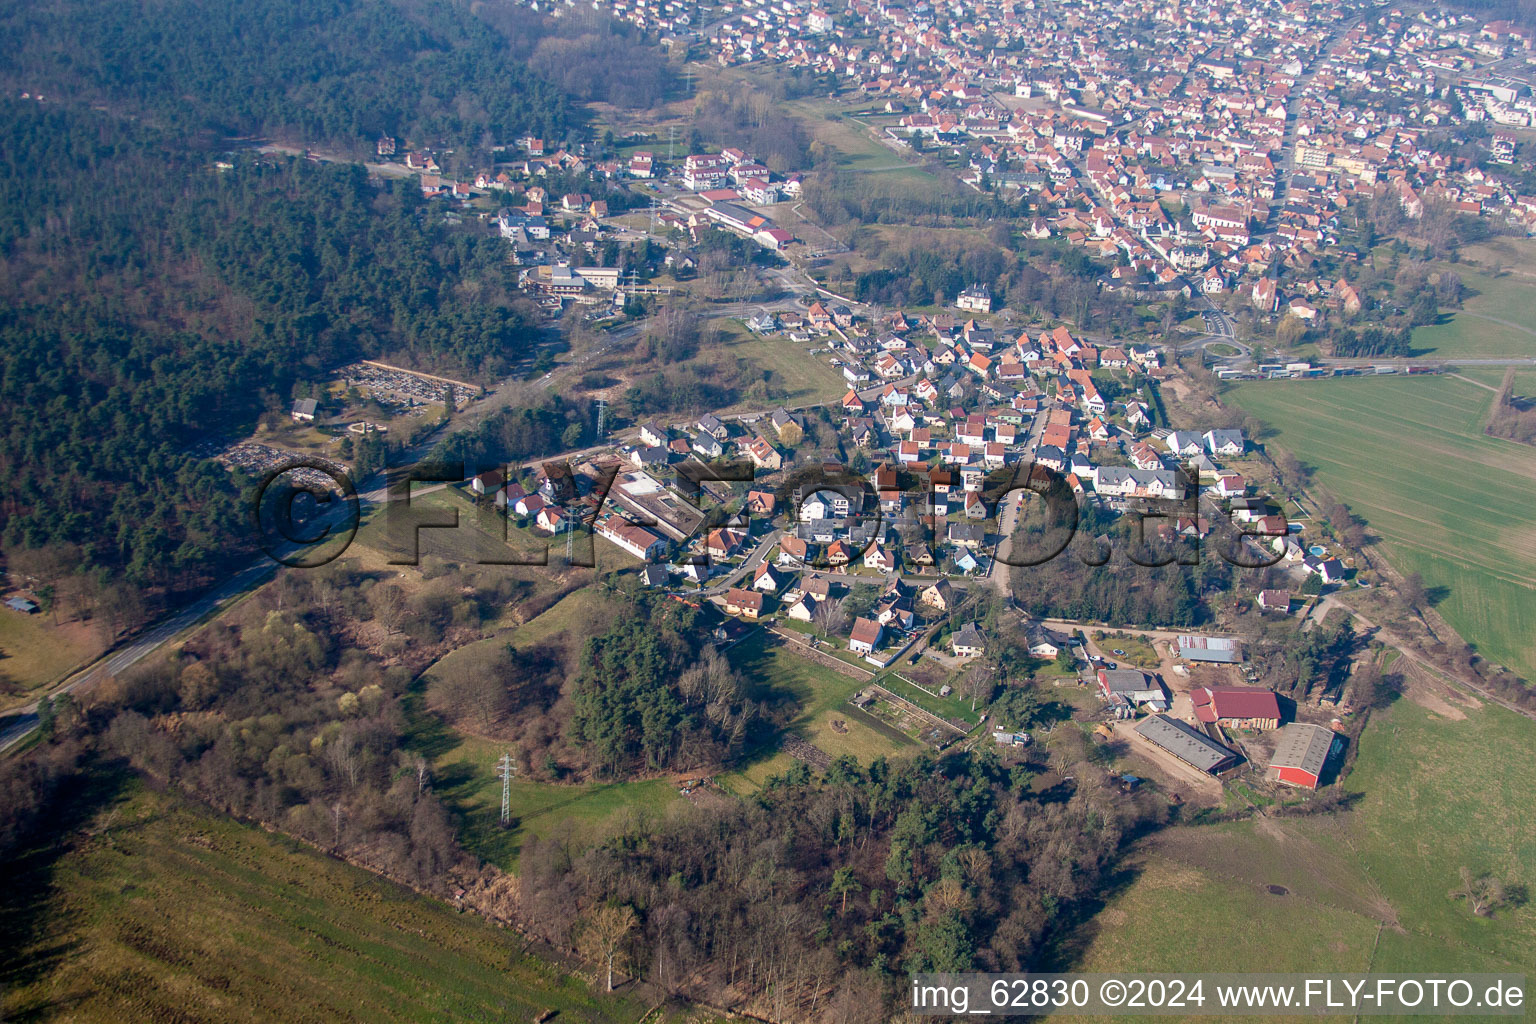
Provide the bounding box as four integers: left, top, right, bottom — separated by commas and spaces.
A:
1227, 376, 1536, 679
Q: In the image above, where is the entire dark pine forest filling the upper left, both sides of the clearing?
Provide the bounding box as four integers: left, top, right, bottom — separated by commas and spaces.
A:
0, 0, 676, 594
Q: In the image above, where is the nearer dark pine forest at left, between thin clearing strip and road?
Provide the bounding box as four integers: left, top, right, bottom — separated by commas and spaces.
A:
0, 100, 538, 588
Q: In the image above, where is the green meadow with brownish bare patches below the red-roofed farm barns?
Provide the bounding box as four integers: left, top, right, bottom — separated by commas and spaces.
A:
1061, 697, 1536, 973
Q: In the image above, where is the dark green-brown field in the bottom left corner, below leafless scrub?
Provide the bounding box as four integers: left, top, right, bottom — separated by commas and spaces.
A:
0, 780, 666, 1024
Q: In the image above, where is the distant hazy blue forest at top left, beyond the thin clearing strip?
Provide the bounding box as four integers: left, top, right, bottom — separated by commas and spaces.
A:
0, 0, 581, 155
